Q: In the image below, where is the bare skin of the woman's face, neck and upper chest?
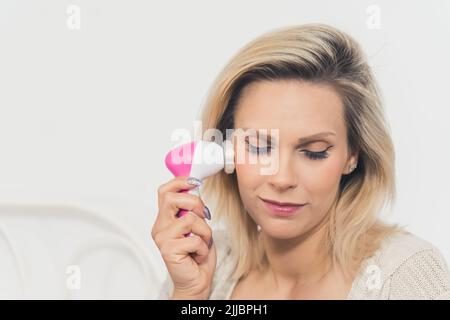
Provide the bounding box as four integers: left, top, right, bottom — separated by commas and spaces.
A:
231, 80, 357, 299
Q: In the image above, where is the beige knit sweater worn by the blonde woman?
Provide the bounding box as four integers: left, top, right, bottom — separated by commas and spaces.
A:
158, 230, 450, 300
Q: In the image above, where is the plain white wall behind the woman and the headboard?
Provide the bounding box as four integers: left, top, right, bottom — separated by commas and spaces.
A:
0, 0, 450, 298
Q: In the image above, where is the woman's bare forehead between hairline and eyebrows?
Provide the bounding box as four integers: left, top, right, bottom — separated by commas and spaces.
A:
235, 80, 345, 135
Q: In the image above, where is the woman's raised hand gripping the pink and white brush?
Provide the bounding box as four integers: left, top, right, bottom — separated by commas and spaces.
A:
151, 177, 216, 299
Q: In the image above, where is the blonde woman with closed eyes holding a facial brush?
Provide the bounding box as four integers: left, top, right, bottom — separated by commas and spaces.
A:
152, 24, 450, 299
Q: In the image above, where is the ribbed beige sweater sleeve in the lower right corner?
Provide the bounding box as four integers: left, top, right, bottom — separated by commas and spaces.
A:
389, 248, 450, 299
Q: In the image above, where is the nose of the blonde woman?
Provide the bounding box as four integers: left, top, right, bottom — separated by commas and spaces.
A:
268, 152, 297, 191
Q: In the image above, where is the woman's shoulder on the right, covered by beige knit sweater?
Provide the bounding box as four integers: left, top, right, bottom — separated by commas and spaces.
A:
352, 232, 450, 299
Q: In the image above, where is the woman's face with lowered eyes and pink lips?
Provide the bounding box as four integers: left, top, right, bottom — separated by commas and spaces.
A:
234, 80, 356, 239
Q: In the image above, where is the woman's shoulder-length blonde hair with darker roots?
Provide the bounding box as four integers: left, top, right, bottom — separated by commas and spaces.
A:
202, 24, 401, 278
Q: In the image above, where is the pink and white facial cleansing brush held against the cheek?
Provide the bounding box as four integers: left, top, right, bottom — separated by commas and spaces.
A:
165, 140, 234, 225
